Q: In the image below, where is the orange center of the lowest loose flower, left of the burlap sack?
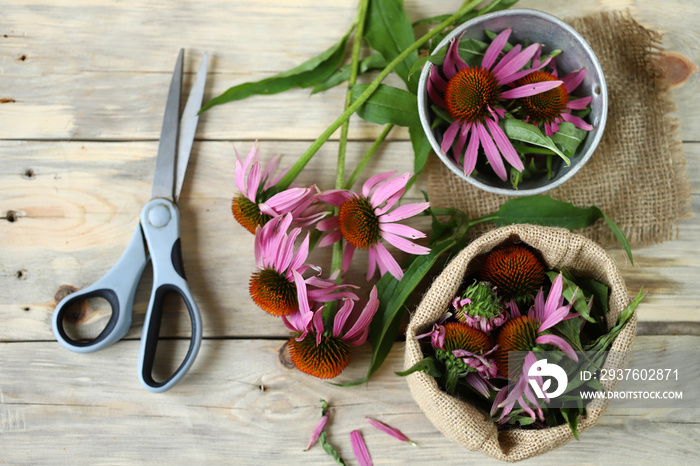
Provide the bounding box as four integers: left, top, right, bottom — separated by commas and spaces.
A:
289, 333, 350, 379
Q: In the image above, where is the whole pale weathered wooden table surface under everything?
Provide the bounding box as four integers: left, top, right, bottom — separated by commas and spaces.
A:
0, 0, 700, 464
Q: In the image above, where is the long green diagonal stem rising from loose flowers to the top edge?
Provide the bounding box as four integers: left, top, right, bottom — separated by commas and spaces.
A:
277, 0, 483, 190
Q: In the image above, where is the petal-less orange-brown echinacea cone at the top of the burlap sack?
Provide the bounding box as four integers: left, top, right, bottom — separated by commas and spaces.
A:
478, 244, 547, 302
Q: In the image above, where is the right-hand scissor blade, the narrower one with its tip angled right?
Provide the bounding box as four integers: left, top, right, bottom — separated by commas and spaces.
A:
174, 53, 209, 202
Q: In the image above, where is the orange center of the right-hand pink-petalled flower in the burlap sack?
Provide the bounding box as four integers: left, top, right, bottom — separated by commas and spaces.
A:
495, 316, 540, 380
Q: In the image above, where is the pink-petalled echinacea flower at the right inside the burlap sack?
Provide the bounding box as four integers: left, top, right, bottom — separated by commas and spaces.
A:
492, 274, 579, 419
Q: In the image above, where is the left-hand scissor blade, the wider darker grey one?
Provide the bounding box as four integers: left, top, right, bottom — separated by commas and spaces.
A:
151, 49, 184, 200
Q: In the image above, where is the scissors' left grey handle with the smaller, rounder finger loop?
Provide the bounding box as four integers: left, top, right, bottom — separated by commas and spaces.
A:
53, 226, 148, 353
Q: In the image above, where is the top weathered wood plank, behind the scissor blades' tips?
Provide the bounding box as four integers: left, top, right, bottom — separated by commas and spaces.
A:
0, 0, 700, 141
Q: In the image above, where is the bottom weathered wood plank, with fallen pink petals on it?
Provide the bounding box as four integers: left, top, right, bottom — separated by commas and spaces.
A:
0, 337, 700, 465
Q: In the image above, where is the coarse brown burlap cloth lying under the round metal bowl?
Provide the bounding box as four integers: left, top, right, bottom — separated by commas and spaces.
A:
428, 12, 690, 246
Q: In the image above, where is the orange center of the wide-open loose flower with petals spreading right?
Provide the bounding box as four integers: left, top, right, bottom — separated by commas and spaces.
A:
338, 197, 379, 249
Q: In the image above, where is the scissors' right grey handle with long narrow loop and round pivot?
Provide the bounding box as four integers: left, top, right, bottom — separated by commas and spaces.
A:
139, 198, 202, 393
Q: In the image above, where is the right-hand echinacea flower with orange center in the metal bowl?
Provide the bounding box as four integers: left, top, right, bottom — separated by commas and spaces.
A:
516, 55, 593, 136
